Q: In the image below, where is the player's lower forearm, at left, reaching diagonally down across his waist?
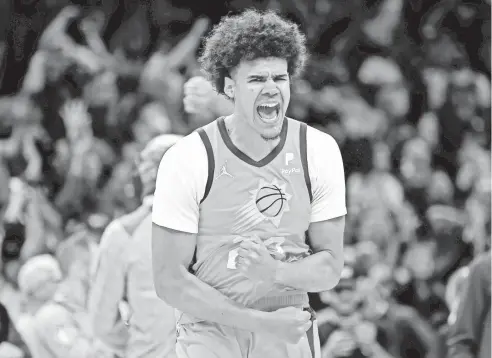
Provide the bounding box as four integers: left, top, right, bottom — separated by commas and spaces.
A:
155, 267, 267, 332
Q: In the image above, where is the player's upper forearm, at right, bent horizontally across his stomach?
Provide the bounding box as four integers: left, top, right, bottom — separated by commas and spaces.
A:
275, 251, 343, 292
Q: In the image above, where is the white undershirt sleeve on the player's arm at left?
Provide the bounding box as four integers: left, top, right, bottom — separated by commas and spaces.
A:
152, 133, 208, 234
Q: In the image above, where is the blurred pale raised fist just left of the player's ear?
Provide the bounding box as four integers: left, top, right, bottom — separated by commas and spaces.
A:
183, 76, 217, 115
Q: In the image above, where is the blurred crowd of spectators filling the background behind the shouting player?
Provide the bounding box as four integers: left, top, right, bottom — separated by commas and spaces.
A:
0, 0, 491, 358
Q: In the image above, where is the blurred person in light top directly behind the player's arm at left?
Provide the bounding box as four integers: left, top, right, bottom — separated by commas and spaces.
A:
89, 135, 180, 358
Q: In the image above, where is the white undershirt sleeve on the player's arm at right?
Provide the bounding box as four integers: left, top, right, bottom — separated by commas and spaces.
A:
306, 127, 347, 223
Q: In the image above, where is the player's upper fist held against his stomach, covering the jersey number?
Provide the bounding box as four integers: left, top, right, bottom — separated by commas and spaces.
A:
236, 237, 280, 284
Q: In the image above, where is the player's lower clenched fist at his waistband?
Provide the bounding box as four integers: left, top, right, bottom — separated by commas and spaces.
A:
262, 307, 312, 344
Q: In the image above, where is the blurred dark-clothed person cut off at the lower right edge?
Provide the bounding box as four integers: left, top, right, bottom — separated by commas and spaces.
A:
448, 251, 491, 358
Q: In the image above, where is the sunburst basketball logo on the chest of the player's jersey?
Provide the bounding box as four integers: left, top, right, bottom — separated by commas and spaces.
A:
233, 179, 292, 234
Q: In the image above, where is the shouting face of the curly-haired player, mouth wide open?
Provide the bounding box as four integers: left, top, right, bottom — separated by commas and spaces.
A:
225, 58, 290, 140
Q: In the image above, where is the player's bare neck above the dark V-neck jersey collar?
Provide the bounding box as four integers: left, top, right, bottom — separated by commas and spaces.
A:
225, 114, 280, 160
